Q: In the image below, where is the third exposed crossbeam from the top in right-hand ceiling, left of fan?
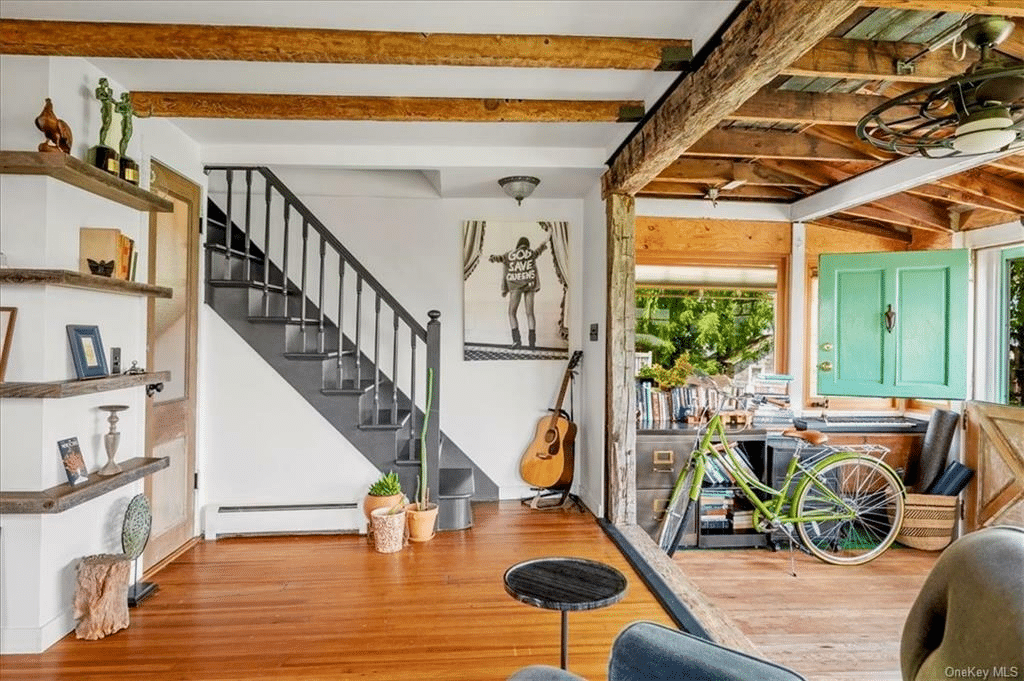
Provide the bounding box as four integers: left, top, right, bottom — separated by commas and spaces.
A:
729, 88, 887, 126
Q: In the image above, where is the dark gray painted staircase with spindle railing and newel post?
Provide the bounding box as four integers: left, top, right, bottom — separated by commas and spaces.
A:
200, 167, 498, 529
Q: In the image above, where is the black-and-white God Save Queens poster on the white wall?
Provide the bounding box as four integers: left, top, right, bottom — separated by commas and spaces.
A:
462, 220, 569, 360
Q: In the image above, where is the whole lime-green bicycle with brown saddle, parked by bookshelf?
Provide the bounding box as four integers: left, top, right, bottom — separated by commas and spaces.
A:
658, 381, 906, 565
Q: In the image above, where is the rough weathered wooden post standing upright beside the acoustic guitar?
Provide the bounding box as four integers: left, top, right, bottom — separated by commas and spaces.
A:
604, 194, 637, 525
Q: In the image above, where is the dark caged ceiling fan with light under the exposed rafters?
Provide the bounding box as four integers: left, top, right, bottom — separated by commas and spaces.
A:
857, 16, 1024, 158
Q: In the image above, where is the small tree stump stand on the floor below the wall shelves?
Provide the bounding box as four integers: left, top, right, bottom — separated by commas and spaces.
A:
75, 553, 131, 641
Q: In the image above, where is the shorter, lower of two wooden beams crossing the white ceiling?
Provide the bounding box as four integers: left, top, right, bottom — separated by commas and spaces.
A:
125, 92, 644, 123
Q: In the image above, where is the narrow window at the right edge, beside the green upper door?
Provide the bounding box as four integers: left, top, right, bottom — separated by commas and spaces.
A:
999, 247, 1024, 407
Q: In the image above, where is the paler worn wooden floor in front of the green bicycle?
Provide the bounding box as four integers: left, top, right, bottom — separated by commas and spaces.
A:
675, 547, 939, 681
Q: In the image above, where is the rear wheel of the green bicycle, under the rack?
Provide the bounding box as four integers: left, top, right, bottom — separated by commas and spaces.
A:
795, 455, 903, 565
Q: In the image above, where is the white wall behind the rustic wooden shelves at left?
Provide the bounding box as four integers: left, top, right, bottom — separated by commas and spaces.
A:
0, 56, 203, 652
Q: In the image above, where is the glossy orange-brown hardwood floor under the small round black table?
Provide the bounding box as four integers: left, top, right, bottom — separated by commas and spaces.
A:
0, 502, 672, 681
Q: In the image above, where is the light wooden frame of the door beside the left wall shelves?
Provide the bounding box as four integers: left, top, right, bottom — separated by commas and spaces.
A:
143, 159, 203, 568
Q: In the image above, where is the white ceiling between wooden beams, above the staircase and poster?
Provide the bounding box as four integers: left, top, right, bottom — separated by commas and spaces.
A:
0, 0, 738, 198
